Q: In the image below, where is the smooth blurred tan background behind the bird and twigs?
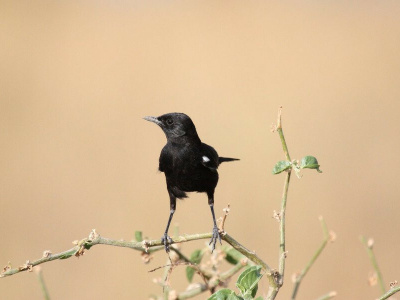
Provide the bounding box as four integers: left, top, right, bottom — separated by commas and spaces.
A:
0, 0, 400, 299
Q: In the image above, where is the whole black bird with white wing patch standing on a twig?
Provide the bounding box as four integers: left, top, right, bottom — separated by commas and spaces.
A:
144, 113, 238, 252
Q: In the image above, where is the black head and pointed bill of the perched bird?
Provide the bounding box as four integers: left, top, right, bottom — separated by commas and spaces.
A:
143, 113, 198, 140
